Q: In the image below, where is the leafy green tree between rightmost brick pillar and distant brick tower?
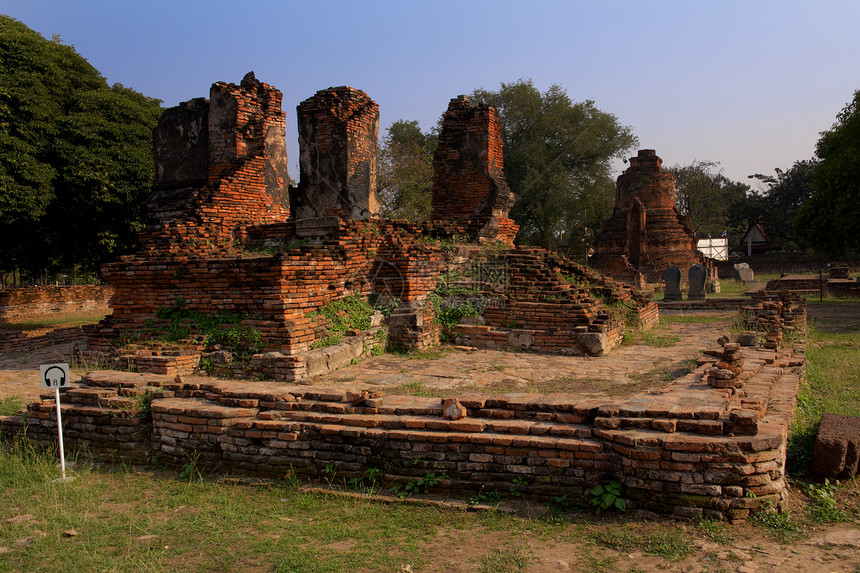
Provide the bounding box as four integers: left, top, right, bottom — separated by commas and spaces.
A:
471, 80, 638, 252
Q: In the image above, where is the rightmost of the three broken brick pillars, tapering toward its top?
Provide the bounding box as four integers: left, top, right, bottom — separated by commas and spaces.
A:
430, 96, 518, 243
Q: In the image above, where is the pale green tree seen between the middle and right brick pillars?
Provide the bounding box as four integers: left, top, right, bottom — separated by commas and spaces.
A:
377, 120, 439, 221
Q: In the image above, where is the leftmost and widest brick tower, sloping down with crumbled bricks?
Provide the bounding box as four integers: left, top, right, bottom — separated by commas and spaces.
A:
140, 72, 290, 254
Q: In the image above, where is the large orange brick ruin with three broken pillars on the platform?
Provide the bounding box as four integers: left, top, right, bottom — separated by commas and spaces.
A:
84, 73, 644, 380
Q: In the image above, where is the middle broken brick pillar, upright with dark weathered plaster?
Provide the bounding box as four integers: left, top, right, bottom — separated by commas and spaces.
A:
293, 86, 379, 219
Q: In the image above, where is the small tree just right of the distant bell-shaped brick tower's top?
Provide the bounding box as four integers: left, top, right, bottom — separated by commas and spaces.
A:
666, 161, 749, 238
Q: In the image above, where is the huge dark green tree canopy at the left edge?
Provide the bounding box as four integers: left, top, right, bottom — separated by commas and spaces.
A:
0, 16, 161, 284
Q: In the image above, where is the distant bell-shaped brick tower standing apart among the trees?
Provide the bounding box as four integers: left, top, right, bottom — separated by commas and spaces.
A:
591, 149, 701, 282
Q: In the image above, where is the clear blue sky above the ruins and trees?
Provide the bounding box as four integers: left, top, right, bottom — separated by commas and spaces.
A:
0, 0, 860, 182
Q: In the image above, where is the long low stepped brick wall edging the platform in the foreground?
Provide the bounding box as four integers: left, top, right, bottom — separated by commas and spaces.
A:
0, 338, 804, 519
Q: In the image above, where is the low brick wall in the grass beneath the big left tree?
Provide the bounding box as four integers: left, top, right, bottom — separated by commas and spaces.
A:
0, 285, 113, 323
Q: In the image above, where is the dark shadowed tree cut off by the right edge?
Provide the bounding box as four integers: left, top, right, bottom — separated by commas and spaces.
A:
794, 90, 860, 255
